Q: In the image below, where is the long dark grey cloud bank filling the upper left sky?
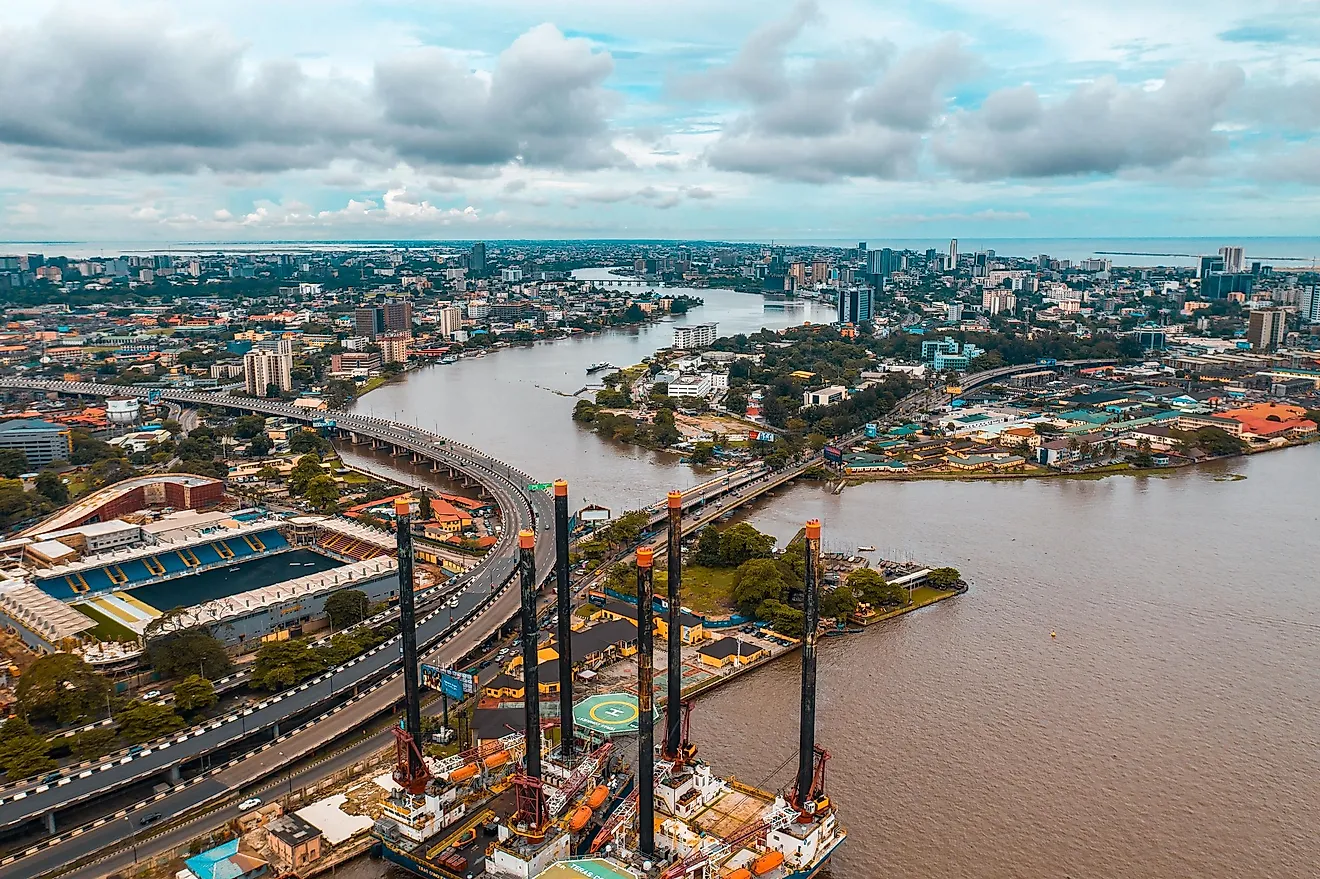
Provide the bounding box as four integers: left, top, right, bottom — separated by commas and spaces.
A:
0, 16, 623, 177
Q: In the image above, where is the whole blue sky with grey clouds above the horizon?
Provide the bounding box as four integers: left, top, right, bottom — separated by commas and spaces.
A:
0, 0, 1320, 242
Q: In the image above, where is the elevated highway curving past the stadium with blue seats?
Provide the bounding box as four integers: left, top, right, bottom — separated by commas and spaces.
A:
0, 379, 554, 849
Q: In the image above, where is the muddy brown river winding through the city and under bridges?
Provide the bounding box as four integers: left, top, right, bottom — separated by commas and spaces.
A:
341, 277, 1320, 879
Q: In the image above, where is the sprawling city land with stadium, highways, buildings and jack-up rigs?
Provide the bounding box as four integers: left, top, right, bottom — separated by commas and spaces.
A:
0, 234, 1320, 879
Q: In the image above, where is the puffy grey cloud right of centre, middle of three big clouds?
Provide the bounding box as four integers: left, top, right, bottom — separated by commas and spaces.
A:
681, 3, 977, 183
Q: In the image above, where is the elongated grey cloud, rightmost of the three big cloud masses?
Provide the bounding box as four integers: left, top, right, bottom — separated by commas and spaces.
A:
933, 65, 1245, 179
